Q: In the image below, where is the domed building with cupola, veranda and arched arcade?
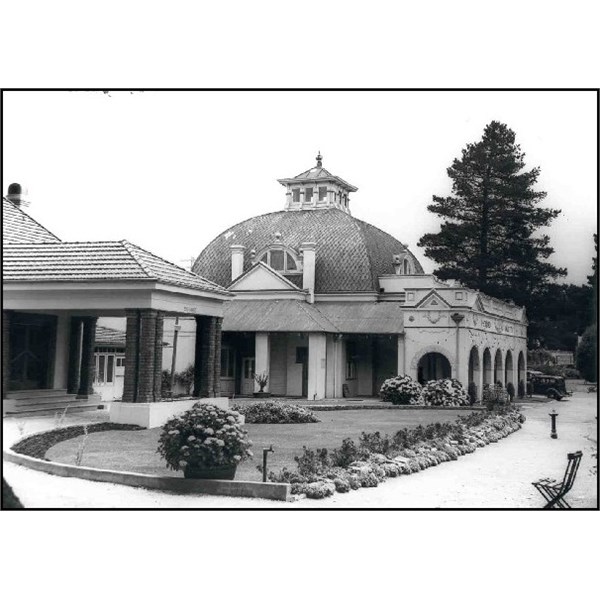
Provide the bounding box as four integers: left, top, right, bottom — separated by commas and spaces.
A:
185, 154, 526, 400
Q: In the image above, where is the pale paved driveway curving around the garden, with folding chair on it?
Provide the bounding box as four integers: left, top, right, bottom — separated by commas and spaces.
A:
3, 392, 598, 508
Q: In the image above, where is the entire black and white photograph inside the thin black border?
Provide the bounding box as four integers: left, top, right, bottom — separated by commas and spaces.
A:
2, 90, 598, 509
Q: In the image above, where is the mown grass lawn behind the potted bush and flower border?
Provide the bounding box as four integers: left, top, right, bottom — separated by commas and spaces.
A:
46, 409, 469, 481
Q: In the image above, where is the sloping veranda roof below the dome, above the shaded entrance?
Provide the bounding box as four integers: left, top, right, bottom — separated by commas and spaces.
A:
223, 299, 404, 334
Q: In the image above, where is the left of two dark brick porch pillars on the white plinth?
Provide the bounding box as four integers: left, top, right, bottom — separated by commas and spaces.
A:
123, 309, 163, 402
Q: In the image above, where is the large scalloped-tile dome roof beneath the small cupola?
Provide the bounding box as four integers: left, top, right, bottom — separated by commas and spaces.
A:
193, 208, 423, 294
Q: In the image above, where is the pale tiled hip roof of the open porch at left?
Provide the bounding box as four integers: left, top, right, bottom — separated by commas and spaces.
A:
2, 240, 227, 293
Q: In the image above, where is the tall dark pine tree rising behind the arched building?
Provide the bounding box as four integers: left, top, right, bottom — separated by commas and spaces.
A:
419, 121, 567, 307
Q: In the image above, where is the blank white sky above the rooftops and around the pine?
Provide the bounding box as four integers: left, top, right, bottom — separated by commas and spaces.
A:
3, 91, 598, 284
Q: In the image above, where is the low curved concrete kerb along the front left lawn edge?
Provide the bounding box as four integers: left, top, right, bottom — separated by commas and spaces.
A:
2, 450, 292, 502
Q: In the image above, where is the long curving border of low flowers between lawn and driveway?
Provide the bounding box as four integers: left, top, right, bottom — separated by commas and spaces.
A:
268, 408, 525, 499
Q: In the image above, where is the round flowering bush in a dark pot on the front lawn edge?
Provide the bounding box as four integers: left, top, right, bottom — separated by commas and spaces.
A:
157, 403, 252, 480
